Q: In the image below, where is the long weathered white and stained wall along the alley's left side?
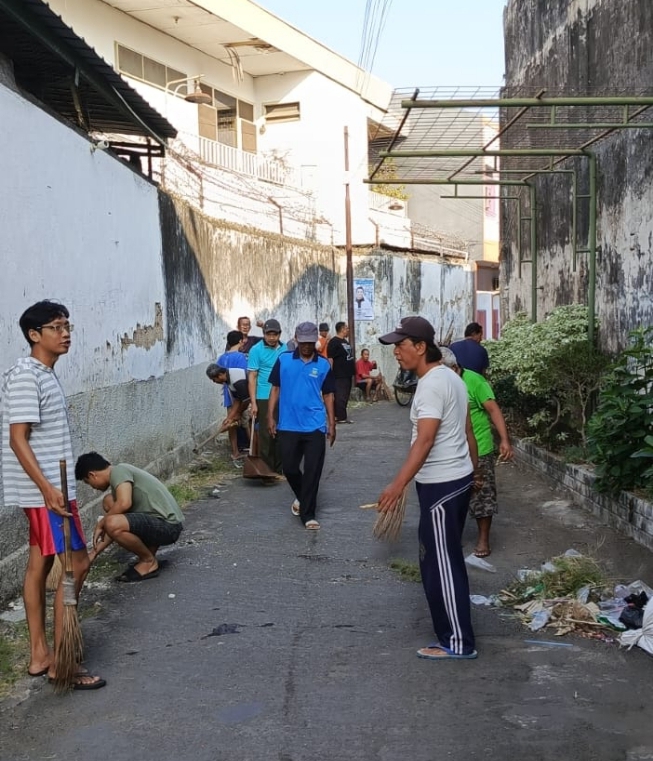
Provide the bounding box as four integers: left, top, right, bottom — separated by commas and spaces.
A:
0, 77, 471, 599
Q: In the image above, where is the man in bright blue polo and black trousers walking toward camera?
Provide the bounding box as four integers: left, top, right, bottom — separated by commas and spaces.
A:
268, 322, 336, 531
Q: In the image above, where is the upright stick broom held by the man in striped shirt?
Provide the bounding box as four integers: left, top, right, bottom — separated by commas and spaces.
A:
54, 460, 84, 692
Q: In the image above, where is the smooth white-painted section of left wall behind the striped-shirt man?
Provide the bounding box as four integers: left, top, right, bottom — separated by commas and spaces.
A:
0, 86, 171, 394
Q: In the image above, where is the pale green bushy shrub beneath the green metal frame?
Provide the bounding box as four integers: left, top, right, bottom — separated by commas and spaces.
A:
486, 305, 609, 449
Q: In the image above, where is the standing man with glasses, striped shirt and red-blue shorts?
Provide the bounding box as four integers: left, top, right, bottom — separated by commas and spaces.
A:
2, 301, 106, 690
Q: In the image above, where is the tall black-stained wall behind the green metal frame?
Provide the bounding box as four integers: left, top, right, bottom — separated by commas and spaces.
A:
501, 0, 653, 350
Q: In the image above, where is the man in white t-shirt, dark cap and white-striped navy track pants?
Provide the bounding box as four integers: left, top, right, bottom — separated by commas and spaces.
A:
378, 317, 478, 661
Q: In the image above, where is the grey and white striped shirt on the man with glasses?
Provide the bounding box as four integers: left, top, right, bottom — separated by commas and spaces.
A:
1, 357, 75, 507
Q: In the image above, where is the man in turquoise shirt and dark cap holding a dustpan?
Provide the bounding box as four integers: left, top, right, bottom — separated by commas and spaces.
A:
247, 319, 285, 476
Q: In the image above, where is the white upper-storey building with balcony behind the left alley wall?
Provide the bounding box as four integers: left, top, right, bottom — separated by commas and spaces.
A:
43, 0, 422, 247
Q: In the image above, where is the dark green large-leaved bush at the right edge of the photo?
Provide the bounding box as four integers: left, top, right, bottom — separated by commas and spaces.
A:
588, 327, 653, 494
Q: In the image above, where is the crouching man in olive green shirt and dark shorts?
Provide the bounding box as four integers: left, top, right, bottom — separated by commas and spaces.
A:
75, 452, 184, 582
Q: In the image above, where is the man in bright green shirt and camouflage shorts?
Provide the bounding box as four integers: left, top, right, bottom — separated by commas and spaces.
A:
440, 346, 514, 558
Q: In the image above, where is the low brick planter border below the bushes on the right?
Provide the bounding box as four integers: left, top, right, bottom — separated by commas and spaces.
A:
515, 441, 653, 550
